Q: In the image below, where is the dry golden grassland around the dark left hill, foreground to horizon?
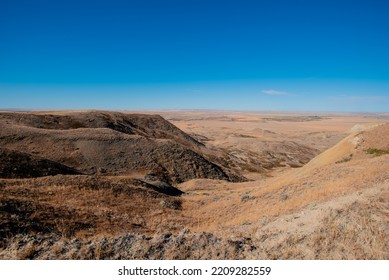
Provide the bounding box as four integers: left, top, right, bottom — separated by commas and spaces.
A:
0, 112, 389, 259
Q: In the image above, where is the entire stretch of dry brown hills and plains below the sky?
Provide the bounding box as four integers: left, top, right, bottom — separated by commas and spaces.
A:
0, 111, 389, 259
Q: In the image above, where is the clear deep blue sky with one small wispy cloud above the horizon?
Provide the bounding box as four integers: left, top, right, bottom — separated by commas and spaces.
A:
0, 0, 389, 112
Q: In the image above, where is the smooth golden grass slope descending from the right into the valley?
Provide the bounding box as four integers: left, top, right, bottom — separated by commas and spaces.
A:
180, 125, 389, 231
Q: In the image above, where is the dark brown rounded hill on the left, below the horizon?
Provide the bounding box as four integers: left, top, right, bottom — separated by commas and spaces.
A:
0, 112, 243, 184
